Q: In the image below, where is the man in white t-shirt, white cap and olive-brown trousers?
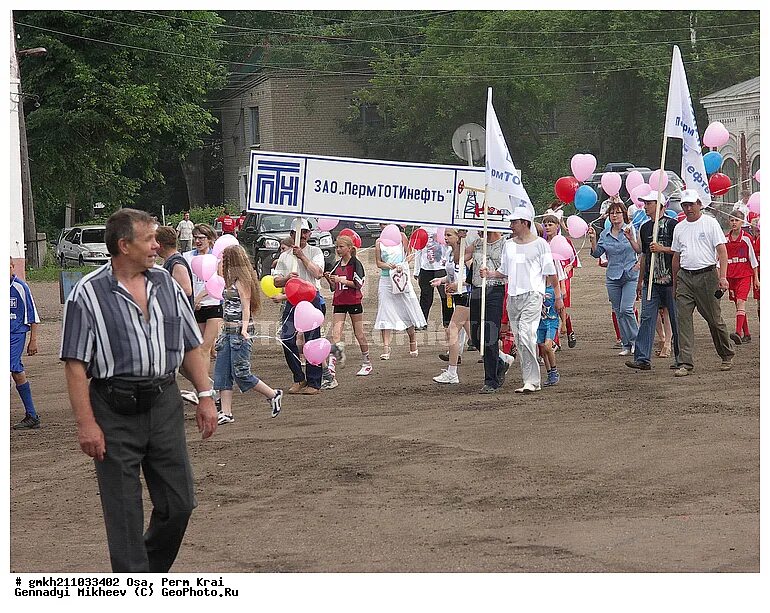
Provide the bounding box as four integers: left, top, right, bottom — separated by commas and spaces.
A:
671, 189, 735, 377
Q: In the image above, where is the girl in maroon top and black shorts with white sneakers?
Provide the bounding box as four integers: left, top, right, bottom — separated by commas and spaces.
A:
321, 236, 372, 389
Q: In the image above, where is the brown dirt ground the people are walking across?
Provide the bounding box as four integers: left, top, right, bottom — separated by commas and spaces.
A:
10, 247, 759, 573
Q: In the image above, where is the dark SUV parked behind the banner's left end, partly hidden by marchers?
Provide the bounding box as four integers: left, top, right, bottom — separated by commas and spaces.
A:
238, 213, 336, 279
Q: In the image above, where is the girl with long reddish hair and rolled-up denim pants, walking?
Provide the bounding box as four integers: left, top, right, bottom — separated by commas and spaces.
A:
214, 245, 283, 425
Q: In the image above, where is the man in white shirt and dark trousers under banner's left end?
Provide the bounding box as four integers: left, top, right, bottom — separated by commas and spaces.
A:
274, 219, 326, 395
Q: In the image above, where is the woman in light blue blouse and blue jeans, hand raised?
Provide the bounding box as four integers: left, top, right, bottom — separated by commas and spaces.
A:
588, 202, 639, 355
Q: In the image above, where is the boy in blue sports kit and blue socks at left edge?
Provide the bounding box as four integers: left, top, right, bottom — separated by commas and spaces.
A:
10, 259, 40, 430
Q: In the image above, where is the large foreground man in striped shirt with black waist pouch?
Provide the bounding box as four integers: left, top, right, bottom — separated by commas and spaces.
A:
60, 209, 217, 572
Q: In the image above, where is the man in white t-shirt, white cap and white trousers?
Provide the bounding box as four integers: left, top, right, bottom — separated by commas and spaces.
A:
480, 206, 564, 394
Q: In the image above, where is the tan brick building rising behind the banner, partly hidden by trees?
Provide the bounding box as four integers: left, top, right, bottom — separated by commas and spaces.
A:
220, 69, 367, 209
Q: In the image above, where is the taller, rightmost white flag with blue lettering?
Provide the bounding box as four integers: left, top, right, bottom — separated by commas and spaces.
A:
664, 45, 711, 206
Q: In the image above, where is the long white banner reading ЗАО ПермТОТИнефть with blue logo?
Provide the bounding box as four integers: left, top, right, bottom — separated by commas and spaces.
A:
247, 151, 511, 230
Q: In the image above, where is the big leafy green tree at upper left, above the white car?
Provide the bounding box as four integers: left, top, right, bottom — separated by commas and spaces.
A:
14, 11, 224, 227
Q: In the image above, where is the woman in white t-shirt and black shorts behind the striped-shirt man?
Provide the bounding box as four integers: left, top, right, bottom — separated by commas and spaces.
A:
182, 223, 222, 358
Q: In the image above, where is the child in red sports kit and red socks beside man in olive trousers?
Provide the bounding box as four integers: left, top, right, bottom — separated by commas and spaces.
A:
725, 210, 759, 345
